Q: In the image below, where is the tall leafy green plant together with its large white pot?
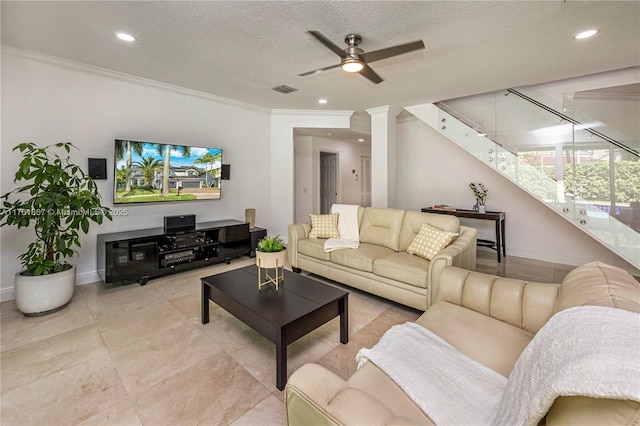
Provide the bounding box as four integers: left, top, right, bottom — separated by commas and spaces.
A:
0, 142, 111, 316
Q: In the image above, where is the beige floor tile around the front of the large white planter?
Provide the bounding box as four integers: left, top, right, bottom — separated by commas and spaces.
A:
0, 291, 93, 351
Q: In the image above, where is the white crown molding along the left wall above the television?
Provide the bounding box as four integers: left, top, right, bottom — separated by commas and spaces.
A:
1, 44, 272, 113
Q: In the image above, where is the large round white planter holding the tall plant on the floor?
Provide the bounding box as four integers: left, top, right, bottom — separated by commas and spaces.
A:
15, 266, 76, 317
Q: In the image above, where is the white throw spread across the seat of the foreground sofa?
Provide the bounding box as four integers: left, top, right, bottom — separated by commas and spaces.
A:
356, 322, 507, 425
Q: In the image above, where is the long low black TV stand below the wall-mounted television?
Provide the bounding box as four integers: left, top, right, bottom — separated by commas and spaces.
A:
97, 220, 251, 287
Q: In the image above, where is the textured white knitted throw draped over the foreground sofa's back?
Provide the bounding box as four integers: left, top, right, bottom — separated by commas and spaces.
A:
491, 306, 640, 425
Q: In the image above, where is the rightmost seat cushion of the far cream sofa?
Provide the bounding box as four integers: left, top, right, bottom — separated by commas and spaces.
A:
373, 252, 429, 288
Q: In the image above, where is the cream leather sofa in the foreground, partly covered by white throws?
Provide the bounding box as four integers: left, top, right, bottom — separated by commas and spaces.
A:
285, 262, 640, 425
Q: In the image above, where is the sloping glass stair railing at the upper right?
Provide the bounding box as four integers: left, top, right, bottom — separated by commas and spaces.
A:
405, 89, 640, 269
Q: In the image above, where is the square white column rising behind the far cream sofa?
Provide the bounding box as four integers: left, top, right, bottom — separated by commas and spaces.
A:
367, 105, 398, 207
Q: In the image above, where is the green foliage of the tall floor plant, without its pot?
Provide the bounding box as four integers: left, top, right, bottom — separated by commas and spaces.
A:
0, 142, 111, 275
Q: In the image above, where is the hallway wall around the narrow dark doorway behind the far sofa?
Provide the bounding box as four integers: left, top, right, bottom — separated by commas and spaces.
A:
295, 136, 371, 223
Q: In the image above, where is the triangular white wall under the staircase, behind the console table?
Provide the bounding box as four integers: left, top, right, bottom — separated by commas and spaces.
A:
396, 118, 637, 273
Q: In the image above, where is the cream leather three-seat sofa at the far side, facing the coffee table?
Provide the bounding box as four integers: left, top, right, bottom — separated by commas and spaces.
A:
287, 207, 477, 310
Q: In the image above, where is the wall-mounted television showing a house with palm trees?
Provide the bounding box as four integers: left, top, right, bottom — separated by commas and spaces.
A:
113, 139, 222, 204
